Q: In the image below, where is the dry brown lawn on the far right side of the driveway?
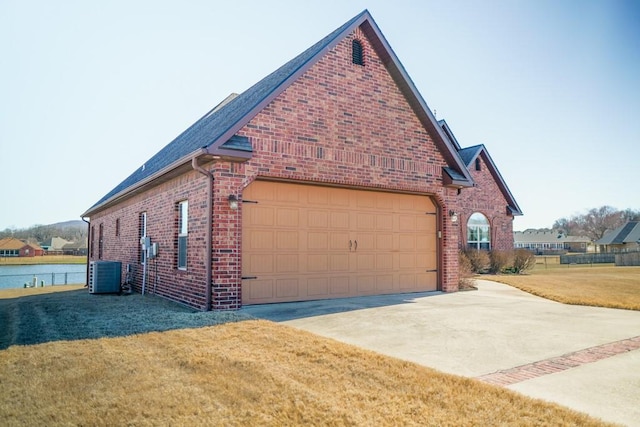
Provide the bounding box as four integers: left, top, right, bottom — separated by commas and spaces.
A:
480, 264, 640, 310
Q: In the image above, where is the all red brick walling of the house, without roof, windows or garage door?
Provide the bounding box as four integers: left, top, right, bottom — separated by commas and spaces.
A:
91, 30, 511, 309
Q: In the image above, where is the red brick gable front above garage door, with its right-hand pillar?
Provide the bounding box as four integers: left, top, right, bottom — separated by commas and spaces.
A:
230, 30, 458, 298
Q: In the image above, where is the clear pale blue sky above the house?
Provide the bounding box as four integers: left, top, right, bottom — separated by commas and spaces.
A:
0, 0, 640, 230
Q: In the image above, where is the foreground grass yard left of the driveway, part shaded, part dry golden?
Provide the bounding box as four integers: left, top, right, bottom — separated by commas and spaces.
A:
0, 287, 607, 426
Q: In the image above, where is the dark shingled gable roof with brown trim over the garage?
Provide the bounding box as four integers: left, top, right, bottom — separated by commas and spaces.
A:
81, 10, 473, 217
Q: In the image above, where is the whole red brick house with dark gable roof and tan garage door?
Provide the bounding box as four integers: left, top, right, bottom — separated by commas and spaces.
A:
82, 11, 520, 310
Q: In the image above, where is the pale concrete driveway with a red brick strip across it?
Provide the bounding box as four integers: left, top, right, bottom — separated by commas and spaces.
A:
243, 280, 640, 426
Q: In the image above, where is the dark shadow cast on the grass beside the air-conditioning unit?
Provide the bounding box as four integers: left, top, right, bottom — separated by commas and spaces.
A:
0, 289, 249, 350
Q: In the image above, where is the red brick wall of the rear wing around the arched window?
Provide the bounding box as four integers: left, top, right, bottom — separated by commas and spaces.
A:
456, 154, 513, 250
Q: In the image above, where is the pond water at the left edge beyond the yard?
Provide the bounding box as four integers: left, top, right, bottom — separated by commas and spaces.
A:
0, 264, 87, 289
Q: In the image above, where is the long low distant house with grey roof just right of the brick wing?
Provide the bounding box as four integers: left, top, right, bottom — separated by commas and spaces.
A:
513, 230, 591, 255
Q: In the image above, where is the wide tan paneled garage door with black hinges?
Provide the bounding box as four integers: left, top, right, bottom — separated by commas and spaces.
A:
242, 181, 437, 305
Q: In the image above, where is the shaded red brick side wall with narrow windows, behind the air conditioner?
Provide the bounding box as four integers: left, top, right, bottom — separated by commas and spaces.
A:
91, 171, 208, 309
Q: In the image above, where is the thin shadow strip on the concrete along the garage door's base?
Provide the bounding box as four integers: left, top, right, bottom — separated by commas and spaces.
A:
240, 291, 442, 322
